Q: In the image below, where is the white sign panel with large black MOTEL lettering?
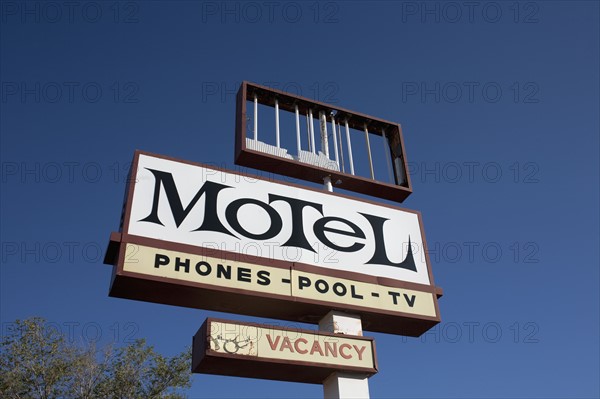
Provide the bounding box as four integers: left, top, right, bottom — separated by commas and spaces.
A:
124, 154, 432, 285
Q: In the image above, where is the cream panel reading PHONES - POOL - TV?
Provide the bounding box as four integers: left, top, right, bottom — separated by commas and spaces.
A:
123, 244, 436, 317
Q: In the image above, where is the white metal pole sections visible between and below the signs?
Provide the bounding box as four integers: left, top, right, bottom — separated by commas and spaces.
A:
319, 119, 370, 399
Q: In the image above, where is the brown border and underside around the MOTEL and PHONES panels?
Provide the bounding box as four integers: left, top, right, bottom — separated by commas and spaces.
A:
104, 150, 443, 336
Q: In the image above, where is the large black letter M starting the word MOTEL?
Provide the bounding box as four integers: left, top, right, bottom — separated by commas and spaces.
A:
140, 168, 235, 237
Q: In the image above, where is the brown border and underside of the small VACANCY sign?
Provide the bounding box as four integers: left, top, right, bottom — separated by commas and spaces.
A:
192, 318, 378, 384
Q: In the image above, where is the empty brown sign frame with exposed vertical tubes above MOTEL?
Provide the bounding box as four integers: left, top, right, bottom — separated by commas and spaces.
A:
235, 82, 412, 202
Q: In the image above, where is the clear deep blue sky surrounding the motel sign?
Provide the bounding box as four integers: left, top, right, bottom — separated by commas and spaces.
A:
0, 0, 600, 398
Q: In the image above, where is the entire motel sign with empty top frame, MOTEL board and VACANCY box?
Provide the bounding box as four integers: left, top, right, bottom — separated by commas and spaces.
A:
105, 82, 442, 397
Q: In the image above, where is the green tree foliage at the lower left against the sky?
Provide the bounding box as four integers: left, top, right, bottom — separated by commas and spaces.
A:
0, 318, 191, 399
